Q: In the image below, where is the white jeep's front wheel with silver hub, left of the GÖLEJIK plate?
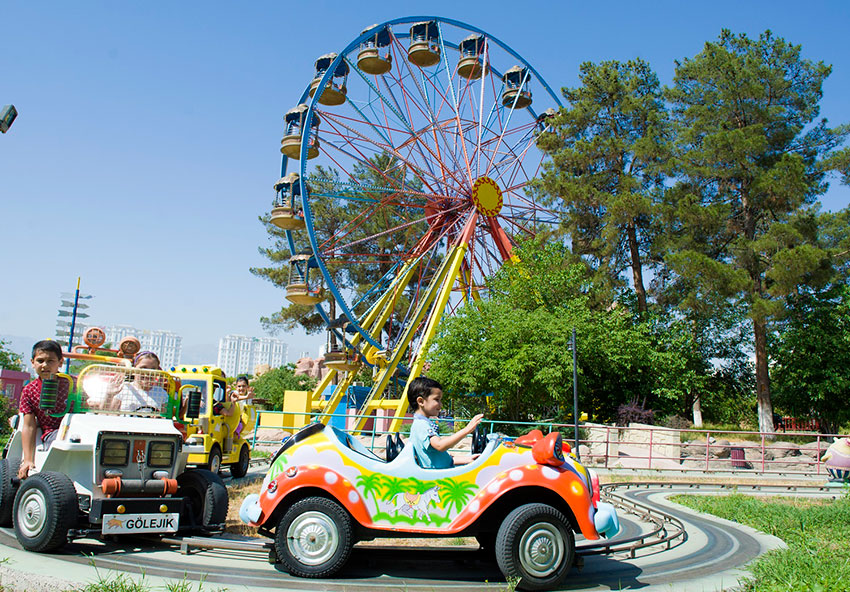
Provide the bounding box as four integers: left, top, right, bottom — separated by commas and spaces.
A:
14, 471, 78, 553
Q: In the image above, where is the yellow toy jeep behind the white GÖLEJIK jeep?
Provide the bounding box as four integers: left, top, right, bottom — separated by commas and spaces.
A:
171, 366, 257, 477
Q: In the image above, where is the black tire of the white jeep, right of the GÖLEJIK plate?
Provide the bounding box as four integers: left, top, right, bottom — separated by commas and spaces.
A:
177, 469, 230, 530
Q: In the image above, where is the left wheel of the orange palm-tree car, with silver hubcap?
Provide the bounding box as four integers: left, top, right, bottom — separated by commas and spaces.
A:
274, 497, 354, 578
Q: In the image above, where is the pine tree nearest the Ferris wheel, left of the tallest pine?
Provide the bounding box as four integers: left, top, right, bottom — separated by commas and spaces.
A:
536, 59, 669, 314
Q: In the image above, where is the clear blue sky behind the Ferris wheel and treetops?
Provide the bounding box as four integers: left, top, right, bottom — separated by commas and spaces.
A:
0, 0, 850, 361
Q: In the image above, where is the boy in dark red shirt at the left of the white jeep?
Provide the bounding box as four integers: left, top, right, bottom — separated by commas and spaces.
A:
18, 339, 71, 479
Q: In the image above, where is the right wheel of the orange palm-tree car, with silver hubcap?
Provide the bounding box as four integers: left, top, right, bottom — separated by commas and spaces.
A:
496, 504, 575, 590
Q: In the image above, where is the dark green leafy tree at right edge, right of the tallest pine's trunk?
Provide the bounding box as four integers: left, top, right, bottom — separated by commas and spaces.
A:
771, 284, 850, 434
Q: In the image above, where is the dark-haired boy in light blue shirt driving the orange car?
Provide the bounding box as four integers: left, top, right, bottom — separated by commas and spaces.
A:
407, 376, 484, 469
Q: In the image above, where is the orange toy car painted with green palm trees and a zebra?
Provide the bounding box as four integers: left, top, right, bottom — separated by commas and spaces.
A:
240, 423, 619, 590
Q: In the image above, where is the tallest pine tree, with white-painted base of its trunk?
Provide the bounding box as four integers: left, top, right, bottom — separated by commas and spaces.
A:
666, 30, 847, 432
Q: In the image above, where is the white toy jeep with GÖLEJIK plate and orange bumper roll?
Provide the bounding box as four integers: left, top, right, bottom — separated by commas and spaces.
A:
0, 364, 228, 552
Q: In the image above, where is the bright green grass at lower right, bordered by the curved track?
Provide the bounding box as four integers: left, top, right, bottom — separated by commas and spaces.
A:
671, 490, 850, 592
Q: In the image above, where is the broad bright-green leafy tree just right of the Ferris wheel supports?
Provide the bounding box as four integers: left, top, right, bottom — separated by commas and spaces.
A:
428, 243, 669, 421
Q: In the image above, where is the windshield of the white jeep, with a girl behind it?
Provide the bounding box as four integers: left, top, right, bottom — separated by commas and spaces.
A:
77, 364, 175, 416
